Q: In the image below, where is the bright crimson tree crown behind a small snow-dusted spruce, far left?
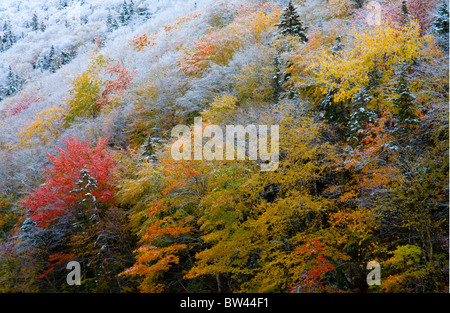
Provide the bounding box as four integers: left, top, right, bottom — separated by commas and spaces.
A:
21, 137, 116, 226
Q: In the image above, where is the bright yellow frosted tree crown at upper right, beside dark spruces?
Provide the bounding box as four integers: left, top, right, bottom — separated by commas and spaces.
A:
306, 20, 440, 108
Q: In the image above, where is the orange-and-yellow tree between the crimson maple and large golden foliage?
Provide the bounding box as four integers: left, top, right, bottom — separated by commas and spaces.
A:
118, 147, 204, 292
